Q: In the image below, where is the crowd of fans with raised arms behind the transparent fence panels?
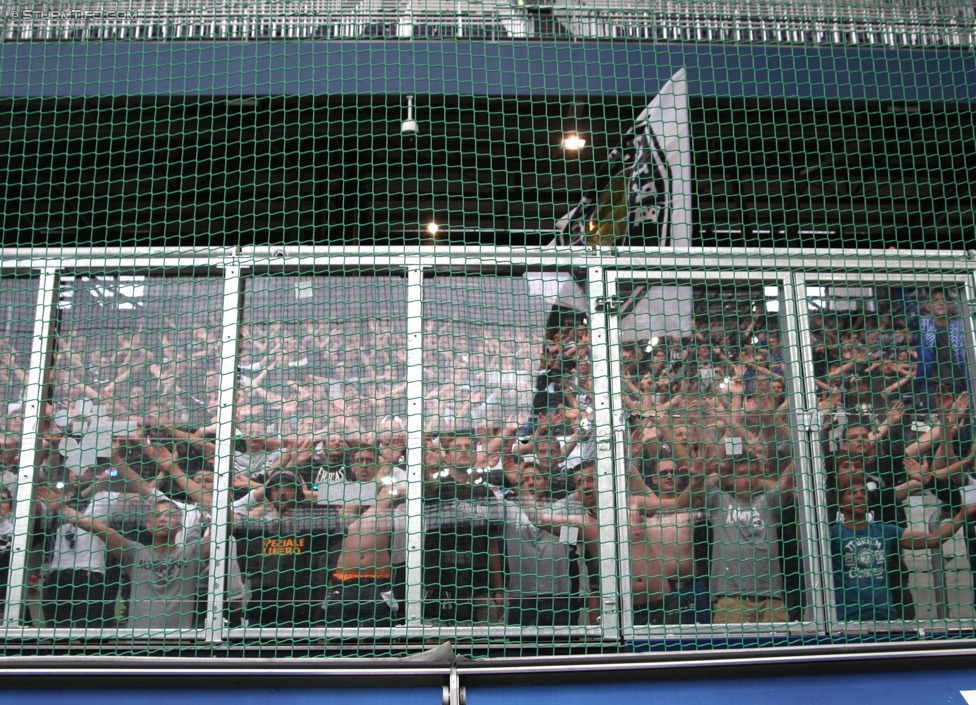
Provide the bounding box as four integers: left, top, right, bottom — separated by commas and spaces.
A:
0, 280, 976, 630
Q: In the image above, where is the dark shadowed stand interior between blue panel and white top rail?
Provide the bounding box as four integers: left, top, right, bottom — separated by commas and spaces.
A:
0, 95, 976, 249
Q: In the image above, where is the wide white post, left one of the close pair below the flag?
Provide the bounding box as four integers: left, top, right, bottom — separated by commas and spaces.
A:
587, 267, 619, 640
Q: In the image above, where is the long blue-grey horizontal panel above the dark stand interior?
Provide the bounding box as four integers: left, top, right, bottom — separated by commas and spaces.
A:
0, 40, 976, 102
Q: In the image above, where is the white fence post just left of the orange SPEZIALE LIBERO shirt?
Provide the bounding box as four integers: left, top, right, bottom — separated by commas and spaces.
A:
206, 264, 242, 641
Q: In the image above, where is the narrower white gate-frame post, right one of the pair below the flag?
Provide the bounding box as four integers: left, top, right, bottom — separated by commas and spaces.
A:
606, 271, 634, 640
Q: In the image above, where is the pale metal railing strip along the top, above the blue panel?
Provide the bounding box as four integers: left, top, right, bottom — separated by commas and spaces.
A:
3, 0, 976, 47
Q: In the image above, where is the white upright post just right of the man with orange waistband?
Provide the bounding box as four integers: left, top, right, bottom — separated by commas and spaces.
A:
406, 266, 424, 627
